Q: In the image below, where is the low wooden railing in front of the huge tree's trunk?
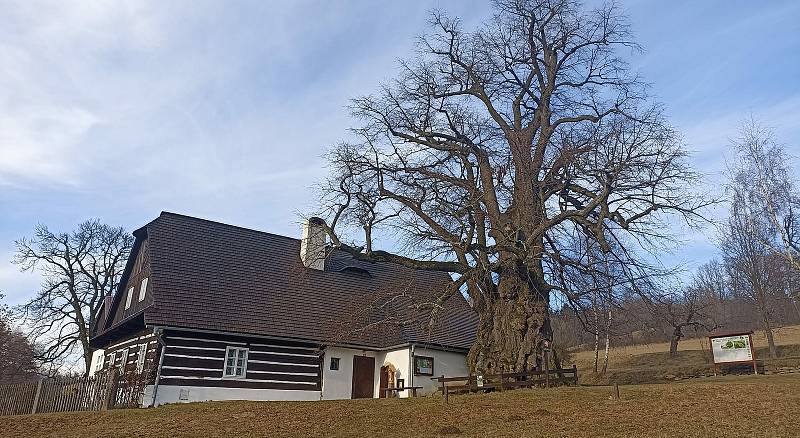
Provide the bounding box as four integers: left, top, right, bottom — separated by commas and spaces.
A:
431, 365, 578, 401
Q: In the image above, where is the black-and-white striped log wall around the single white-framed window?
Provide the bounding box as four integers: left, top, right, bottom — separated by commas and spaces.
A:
159, 330, 321, 394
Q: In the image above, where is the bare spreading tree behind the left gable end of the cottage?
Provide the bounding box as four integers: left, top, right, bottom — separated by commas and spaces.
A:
14, 220, 133, 373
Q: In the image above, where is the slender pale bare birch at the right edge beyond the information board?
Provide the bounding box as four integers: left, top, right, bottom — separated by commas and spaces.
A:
721, 117, 800, 357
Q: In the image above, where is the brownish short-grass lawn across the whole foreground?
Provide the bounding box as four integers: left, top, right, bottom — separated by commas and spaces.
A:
0, 375, 800, 438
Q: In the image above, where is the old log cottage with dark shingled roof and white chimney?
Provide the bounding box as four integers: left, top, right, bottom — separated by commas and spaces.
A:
91, 212, 477, 405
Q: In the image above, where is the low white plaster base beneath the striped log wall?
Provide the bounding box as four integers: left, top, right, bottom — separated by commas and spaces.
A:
152, 385, 320, 406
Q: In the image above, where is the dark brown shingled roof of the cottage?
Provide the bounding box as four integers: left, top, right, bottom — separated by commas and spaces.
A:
97, 212, 477, 348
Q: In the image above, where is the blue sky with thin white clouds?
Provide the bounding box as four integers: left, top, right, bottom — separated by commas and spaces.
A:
0, 0, 800, 305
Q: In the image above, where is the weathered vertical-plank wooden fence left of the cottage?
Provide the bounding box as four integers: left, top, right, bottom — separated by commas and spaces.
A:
0, 370, 147, 415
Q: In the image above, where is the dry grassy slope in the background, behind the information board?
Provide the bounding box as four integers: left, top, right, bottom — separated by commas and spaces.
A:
573, 326, 800, 384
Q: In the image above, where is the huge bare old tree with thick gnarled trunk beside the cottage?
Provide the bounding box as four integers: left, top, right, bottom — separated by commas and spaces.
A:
316, 0, 704, 372
